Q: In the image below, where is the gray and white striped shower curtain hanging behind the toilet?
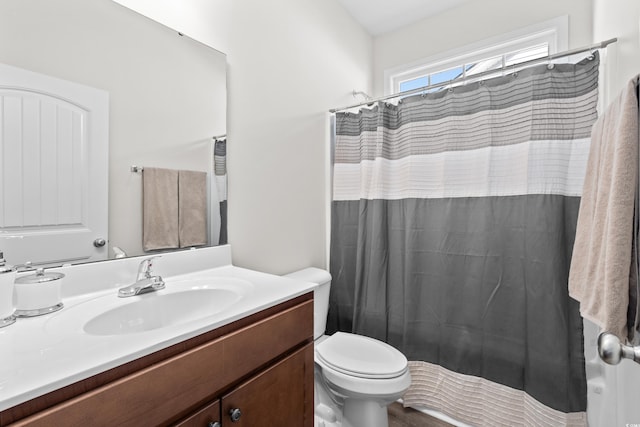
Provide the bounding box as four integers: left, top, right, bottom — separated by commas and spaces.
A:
328, 55, 599, 426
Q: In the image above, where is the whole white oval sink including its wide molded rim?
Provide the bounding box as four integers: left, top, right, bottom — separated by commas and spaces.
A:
45, 278, 253, 336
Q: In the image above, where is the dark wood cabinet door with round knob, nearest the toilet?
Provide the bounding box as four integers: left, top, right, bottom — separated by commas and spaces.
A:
222, 343, 313, 427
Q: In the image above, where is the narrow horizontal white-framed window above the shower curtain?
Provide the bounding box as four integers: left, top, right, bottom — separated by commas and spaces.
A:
385, 16, 568, 95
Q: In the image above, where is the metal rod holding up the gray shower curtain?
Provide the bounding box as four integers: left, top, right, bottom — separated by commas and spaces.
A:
329, 37, 618, 113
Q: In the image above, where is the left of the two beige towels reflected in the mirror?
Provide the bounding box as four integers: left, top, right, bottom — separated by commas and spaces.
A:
142, 167, 179, 251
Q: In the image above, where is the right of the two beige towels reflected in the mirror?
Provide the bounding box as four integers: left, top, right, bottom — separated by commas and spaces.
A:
178, 171, 207, 248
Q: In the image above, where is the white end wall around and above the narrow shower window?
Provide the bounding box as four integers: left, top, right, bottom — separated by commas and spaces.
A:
373, 0, 591, 96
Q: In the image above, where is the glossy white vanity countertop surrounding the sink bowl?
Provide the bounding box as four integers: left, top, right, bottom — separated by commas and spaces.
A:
0, 247, 315, 411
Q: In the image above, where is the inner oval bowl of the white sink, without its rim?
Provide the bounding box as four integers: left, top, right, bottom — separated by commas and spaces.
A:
83, 289, 241, 335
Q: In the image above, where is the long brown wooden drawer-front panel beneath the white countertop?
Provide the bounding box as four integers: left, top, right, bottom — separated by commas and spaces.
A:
15, 300, 313, 426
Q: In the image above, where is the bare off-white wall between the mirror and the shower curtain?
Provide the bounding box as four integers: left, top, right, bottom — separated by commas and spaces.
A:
227, 0, 372, 273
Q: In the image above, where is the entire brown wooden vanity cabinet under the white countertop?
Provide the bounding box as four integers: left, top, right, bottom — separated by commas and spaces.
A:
0, 293, 314, 427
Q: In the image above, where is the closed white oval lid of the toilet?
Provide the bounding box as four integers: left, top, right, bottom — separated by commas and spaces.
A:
316, 332, 407, 378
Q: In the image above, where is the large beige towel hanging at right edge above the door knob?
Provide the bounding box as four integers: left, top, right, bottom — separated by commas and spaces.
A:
569, 79, 638, 339
